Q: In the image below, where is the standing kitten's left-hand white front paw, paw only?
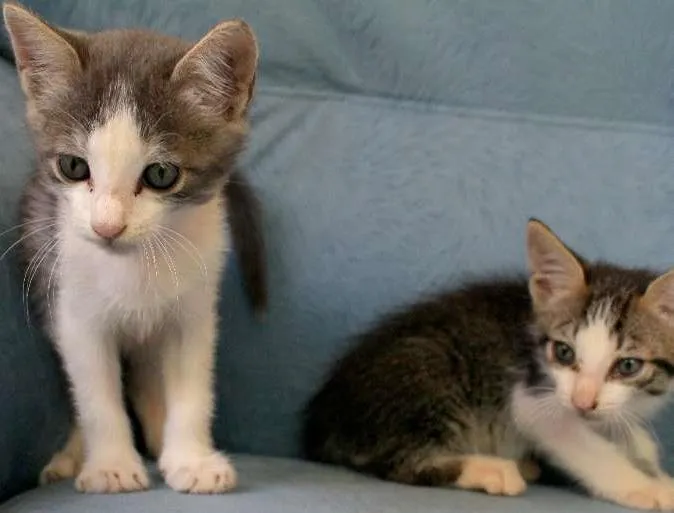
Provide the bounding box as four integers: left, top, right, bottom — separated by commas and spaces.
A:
75, 455, 150, 493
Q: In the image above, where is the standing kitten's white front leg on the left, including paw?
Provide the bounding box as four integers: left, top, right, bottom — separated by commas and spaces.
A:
56, 308, 149, 493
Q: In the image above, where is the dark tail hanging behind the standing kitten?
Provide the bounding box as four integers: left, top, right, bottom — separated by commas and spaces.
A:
225, 170, 269, 316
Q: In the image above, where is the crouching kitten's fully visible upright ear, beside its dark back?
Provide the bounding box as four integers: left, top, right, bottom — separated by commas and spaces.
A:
527, 219, 586, 307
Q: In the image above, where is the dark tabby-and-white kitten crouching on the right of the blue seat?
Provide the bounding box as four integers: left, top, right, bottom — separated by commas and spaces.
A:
303, 220, 674, 510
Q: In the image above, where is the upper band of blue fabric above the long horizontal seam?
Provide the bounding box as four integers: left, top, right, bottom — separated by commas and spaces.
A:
3, 0, 674, 124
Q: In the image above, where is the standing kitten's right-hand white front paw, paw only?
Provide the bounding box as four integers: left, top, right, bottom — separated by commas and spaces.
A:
159, 451, 237, 493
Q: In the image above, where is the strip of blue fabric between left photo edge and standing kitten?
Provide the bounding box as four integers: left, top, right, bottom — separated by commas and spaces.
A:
0, 62, 67, 502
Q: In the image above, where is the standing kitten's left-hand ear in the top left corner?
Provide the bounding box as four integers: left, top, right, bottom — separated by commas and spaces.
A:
2, 2, 82, 100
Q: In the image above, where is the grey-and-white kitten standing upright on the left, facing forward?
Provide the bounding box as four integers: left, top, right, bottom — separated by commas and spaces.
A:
4, 3, 266, 493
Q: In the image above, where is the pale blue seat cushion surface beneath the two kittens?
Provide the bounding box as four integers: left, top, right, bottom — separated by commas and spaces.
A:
0, 456, 625, 513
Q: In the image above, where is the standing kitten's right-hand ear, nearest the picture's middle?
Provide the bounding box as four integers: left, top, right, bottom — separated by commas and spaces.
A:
171, 20, 258, 119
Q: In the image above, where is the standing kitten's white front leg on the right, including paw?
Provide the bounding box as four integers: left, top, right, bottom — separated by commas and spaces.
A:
159, 293, 236, 493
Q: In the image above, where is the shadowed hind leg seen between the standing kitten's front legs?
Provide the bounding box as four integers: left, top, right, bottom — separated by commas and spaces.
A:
128, 344, 166, 458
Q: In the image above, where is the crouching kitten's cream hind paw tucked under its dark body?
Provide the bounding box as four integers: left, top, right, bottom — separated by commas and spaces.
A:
456, 456, 527, 495
